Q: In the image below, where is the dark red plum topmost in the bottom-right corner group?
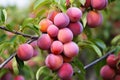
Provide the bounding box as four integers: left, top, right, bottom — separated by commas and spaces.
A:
106, 54, 118, 68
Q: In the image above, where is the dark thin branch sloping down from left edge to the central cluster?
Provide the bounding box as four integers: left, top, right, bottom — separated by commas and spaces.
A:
0, 26, 38, 39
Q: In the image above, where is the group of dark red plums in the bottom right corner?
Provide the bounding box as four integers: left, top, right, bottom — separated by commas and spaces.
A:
100, 54, 120, 80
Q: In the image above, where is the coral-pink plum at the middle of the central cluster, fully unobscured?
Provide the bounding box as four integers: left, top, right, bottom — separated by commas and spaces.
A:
58, 28, 73, 43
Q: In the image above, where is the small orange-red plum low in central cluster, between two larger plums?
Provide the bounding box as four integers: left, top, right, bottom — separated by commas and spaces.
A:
51, 41, 63, 55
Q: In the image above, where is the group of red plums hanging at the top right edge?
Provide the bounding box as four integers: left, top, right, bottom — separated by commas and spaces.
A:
83, 0, 108, 28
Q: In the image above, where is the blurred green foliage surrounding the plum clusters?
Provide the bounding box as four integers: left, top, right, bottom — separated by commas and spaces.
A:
0, 0, 120, 80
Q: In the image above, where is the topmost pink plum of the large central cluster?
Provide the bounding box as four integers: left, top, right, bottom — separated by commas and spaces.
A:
66, 7, 82, 22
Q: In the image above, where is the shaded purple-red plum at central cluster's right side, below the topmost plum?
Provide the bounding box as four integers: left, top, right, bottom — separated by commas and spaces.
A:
68, 21, 83, 36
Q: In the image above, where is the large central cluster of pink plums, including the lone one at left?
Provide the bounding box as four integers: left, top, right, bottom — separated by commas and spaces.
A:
17, 7, 83, 80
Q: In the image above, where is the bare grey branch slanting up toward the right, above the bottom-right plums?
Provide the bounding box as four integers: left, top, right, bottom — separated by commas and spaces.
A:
78, 49, 116, 73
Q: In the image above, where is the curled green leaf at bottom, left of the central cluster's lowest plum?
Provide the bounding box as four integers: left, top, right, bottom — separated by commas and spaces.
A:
36, 66, 50, 80
